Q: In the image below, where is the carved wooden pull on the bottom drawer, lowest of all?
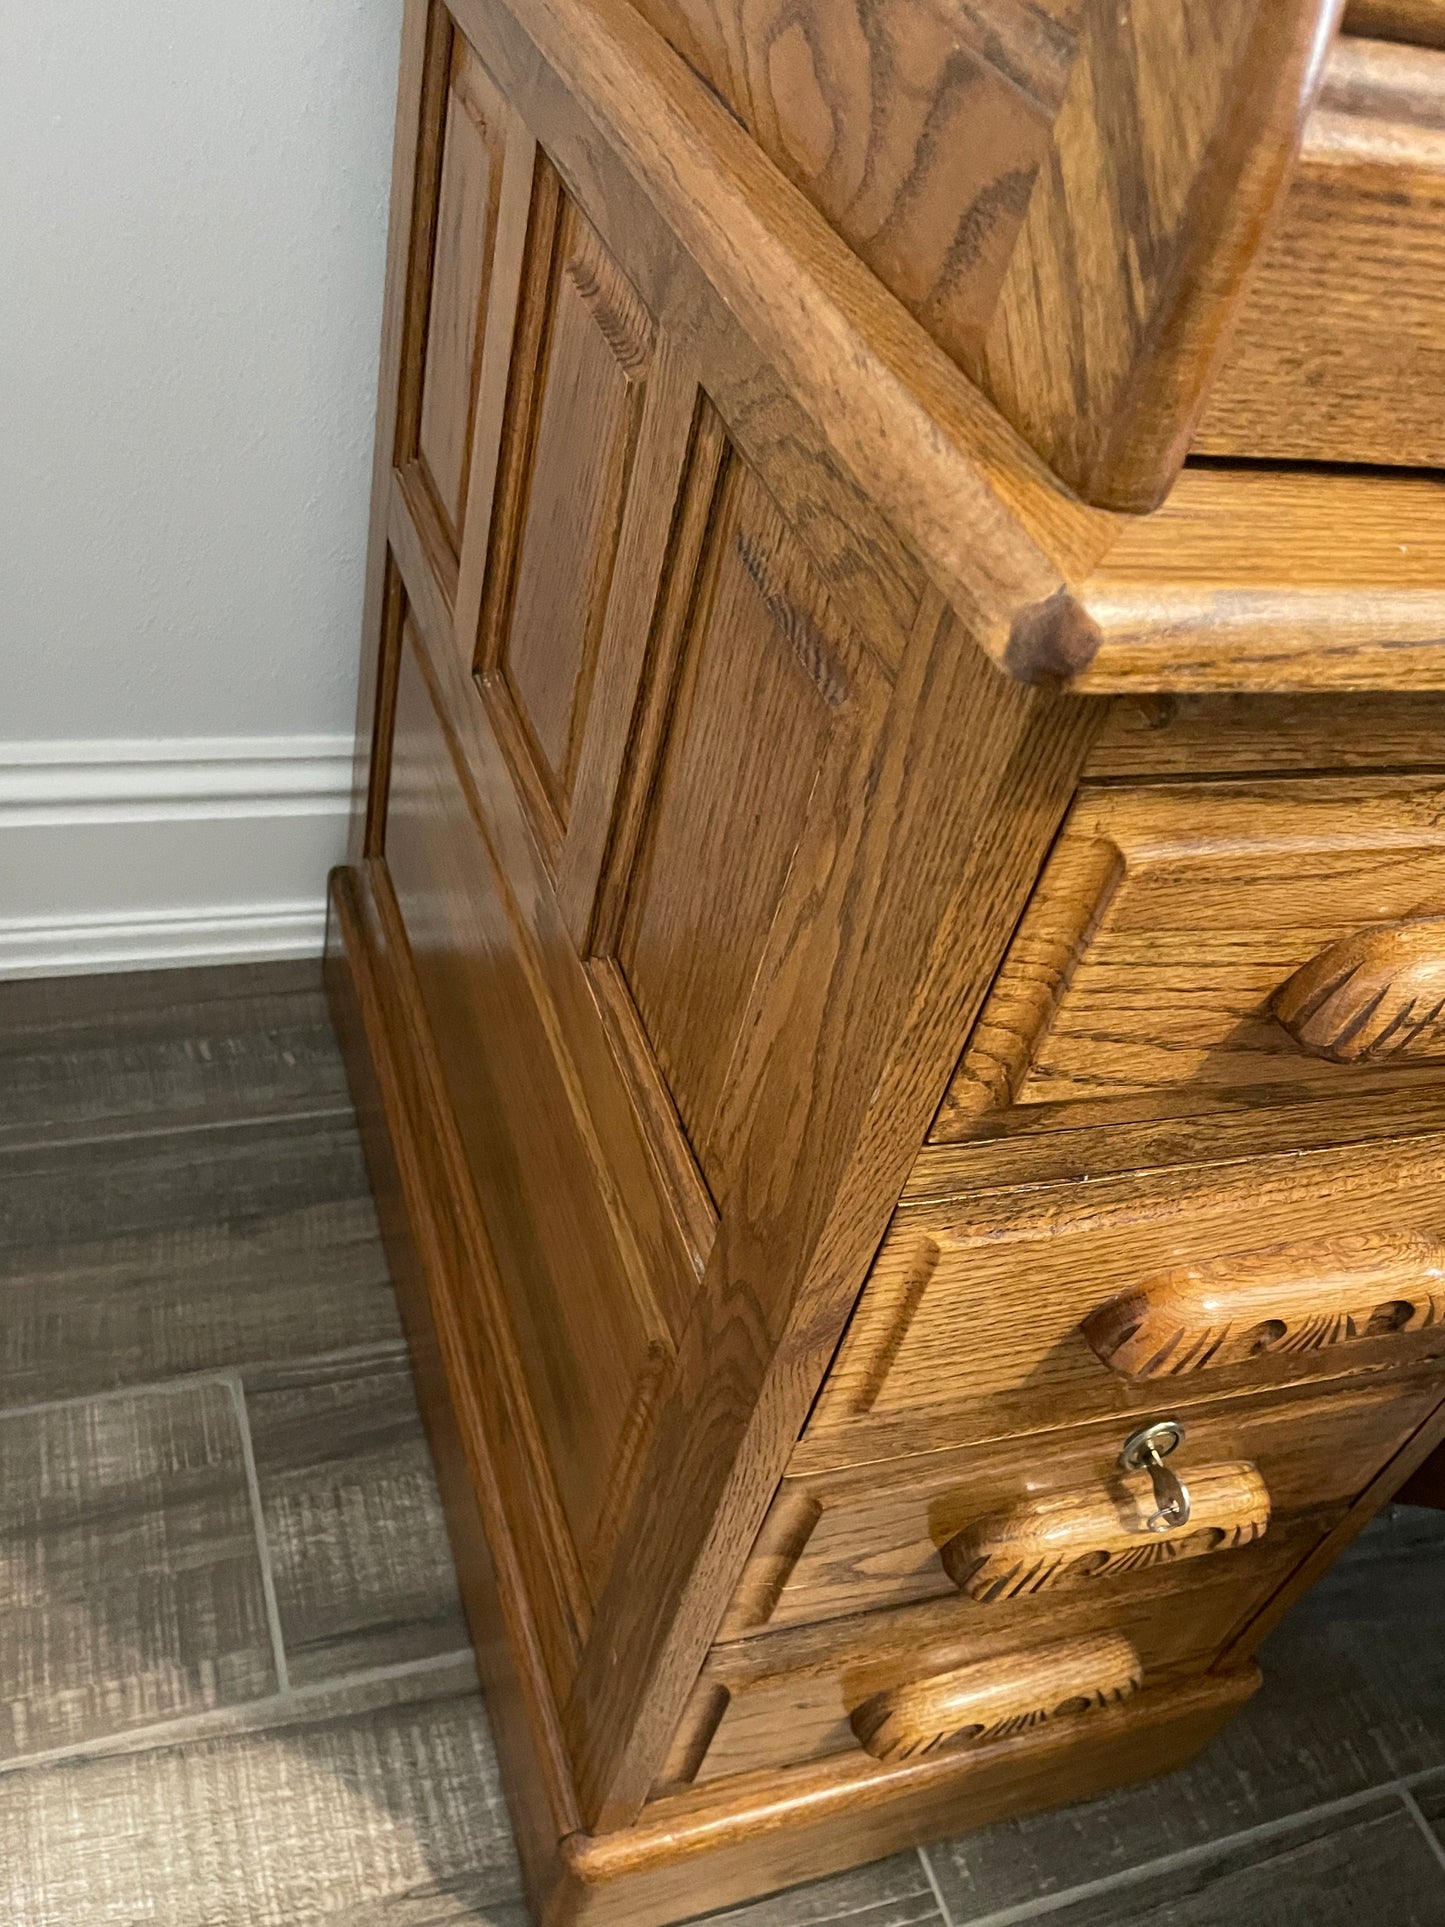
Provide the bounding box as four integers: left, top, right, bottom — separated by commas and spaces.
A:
852, 1632, 1143, 1761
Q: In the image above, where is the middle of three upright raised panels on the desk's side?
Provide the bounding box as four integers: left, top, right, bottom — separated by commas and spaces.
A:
480, 185, 653, 834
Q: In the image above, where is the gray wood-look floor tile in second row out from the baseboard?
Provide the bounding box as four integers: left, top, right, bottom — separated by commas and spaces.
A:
0, 1120, 401, 1409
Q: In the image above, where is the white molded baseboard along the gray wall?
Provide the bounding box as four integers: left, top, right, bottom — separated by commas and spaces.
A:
0, 736, 351, 977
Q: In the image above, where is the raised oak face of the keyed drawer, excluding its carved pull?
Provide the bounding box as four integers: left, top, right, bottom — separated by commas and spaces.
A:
739, 1374, 1441, 1638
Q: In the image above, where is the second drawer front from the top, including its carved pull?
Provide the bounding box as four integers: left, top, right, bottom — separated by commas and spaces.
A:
794, 1135, 1445, 1472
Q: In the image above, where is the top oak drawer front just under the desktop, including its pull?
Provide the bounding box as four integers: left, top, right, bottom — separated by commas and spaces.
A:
934, 777, 1445, 1139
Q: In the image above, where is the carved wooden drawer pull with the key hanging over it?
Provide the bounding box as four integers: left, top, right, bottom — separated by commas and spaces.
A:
938, 1428, 1270, 1605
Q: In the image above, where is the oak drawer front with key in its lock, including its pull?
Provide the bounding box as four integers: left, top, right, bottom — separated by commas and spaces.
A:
739, 1374, 1445, 1638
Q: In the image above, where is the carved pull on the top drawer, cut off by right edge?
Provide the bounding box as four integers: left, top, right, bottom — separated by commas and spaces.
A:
1272, 915, 1445, 1064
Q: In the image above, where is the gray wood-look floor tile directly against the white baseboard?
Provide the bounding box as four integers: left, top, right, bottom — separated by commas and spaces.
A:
0, 962, 347, 1150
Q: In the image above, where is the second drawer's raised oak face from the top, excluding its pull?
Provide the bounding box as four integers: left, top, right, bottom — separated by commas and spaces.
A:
794, 1137, 1445, 1470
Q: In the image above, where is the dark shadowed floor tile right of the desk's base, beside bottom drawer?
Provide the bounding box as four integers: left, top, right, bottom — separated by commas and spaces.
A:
929, 1507, 1445, 1927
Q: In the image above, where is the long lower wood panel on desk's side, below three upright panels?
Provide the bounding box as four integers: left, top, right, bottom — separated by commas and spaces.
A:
385, 638, 672, 1586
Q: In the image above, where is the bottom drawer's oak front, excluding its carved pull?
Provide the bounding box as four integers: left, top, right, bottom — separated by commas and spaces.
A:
674, 1520, 1322, 1790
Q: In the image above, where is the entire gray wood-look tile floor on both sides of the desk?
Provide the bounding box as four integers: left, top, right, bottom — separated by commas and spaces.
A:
0, 965, 1445, 1927
